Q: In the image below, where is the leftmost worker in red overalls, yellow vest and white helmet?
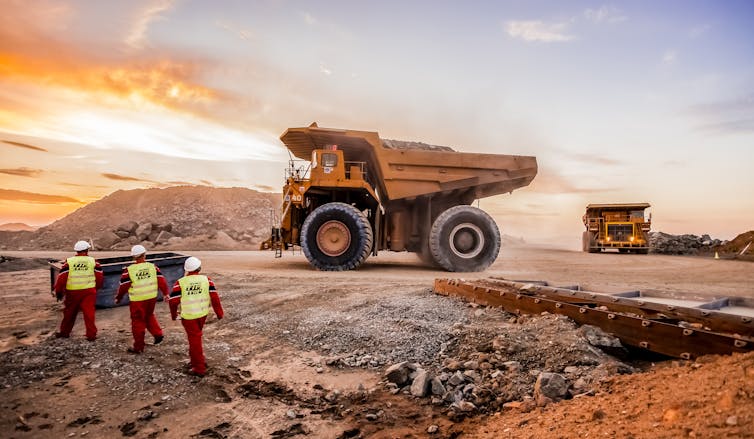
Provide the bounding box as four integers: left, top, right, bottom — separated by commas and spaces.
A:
53, 241, 105, 341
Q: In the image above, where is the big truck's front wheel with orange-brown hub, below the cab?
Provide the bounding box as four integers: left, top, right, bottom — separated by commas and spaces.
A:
301, 203, 373, 271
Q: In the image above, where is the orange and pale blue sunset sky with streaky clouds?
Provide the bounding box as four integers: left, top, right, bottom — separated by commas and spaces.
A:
0, 0, 754, 248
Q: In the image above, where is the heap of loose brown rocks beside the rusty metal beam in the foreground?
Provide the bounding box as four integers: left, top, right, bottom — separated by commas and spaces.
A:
384, 314, 634, 419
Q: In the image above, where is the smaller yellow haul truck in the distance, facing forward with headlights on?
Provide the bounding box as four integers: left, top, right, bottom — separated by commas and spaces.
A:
582, 203, 652, 254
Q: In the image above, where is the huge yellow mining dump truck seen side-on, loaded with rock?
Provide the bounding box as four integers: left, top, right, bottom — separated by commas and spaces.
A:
263, 123, 537, 271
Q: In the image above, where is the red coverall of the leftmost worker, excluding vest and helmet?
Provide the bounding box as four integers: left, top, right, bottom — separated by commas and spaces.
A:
53, 254, 105, 341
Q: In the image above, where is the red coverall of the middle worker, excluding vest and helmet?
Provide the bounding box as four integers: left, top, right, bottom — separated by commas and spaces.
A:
115, 267, 168, 352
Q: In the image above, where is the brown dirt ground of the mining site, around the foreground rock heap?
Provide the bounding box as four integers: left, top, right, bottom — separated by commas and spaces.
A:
0, 247, 754, 438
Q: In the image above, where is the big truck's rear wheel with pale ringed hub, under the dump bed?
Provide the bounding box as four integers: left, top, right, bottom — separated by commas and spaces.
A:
429, 206, 500, 271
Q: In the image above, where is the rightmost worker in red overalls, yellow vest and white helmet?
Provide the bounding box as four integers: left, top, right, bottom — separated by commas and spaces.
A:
168, 256, 224, 377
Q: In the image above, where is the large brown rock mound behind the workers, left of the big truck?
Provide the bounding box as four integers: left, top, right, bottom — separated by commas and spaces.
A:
0, 186, 281, 250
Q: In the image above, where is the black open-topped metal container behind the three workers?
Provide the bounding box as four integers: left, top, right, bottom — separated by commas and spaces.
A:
50, 252, 188, 308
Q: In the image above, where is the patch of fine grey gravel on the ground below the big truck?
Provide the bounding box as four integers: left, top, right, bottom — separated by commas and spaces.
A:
230, 288, 468, 367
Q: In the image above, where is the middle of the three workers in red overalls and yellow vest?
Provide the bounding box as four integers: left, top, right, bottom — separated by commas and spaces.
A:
115, 245, 168, 354
